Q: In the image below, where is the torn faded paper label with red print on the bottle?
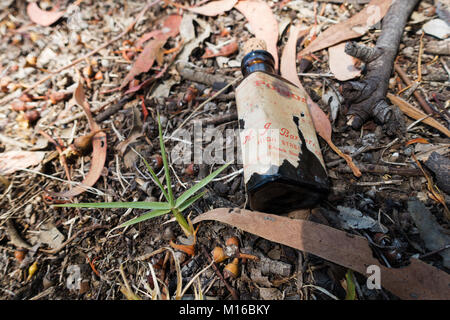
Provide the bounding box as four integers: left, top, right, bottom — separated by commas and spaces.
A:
236, 72, 326, 183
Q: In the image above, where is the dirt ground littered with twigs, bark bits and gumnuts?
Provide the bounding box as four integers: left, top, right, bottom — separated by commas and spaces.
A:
0, 0, 450, 300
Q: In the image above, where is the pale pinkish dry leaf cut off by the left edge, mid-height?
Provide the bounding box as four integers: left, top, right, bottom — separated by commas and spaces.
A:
0, 150, 45, 175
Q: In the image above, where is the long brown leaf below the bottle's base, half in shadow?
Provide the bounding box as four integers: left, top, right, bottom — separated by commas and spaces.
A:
193, 208, 450, 300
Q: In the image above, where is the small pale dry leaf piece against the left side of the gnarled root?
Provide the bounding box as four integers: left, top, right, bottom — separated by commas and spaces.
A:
328, 42, 361, 81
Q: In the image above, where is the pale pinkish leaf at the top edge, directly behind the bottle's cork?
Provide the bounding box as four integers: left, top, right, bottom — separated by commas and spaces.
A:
235, 0, 278, 70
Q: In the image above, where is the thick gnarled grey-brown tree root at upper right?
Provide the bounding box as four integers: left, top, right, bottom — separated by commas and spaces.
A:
340, 0, 418, 135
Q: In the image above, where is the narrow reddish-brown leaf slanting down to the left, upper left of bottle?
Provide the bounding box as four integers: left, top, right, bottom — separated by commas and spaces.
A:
120, 15, 182, 89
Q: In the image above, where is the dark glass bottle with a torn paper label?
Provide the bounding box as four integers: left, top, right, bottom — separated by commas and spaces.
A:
236, 50, 329, 213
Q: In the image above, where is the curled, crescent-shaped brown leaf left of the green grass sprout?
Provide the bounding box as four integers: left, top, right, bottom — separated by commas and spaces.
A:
46, 82, 107, 198
